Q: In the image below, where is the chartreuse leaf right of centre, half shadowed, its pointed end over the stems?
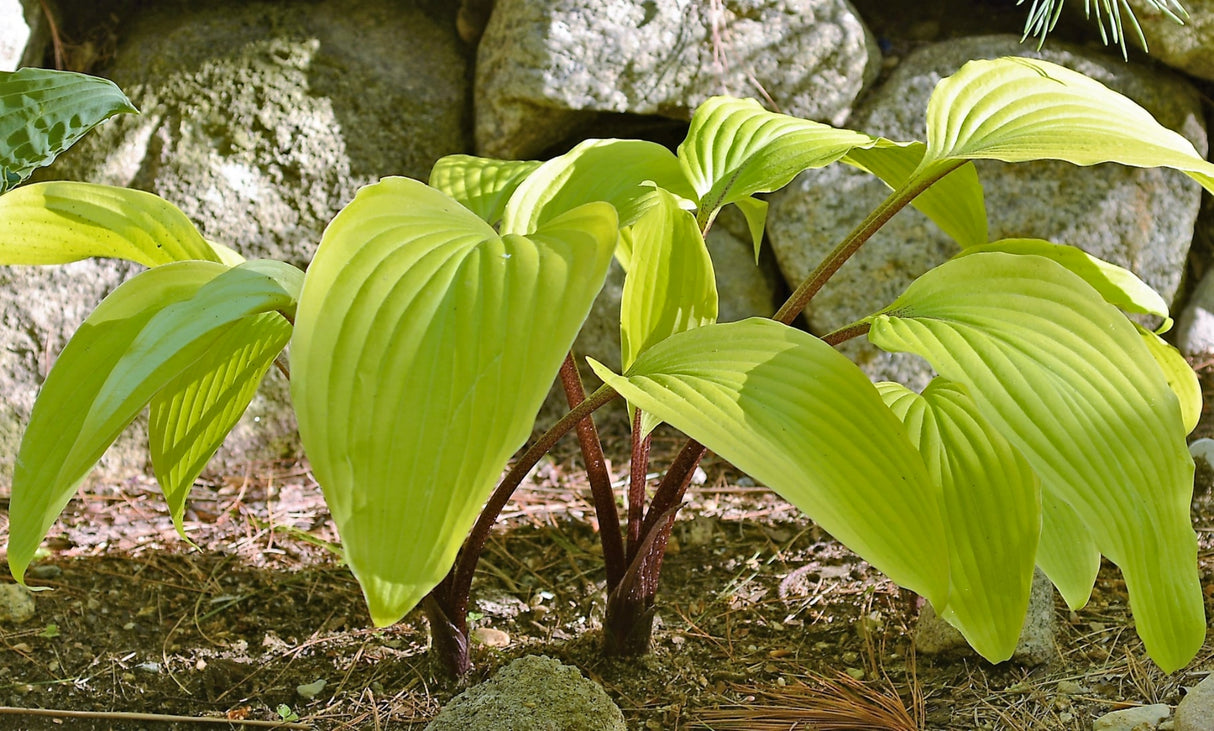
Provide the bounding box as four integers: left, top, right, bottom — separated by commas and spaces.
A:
590, 319, 948, 606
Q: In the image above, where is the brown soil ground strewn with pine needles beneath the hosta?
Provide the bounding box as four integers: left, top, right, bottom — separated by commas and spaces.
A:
0, 368, 1214, 731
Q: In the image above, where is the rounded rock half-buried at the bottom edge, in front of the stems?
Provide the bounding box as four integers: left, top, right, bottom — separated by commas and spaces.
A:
426, 655, 625, 731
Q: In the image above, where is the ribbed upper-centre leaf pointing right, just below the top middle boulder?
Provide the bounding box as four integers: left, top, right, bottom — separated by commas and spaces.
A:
679, 96, 879, 227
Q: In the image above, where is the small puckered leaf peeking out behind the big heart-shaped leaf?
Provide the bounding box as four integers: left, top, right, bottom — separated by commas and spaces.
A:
430, 154, 540, 223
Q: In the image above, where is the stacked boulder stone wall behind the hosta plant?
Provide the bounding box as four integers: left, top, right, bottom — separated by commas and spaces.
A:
0, 0, 1214, 482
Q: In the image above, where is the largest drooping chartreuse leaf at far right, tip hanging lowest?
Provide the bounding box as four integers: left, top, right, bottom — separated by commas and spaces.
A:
869, 253, 1206, 672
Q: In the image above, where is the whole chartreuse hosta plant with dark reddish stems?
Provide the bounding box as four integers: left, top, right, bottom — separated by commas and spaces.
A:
0, 58, 1214, 673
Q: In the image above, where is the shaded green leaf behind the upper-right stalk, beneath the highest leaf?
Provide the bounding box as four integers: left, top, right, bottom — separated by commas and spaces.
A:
843, 142, 988, 247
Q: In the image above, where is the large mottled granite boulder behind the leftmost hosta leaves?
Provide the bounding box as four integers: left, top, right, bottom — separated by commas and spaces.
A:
0, 0, 467, 480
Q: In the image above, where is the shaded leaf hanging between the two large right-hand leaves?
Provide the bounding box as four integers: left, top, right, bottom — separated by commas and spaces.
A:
878, 378, 1042, 663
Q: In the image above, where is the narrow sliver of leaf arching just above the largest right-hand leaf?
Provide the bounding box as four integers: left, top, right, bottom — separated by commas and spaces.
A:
957, 238, 1172, 333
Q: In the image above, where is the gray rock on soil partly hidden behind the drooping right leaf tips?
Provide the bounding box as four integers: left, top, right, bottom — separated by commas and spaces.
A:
914, 568, 1057, 668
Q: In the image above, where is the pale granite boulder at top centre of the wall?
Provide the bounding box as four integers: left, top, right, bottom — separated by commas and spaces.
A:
476, 0, 880, 158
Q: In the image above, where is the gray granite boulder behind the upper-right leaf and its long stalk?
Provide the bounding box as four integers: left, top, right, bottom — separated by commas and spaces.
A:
767, 36, 1207, 389
